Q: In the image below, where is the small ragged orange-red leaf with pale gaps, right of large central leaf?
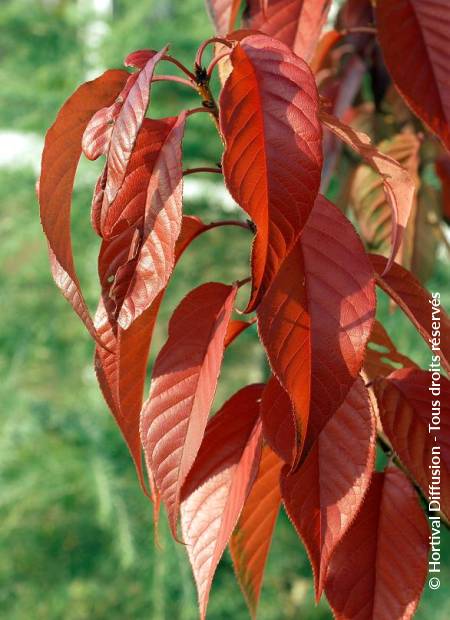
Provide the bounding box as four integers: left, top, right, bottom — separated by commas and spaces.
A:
364, 321, 416, 380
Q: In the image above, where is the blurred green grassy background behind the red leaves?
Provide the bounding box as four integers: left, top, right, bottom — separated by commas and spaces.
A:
0, 0, 450, 620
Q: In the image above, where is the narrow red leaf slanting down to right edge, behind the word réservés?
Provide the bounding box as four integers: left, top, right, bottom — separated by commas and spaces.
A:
370, 254, 450, 373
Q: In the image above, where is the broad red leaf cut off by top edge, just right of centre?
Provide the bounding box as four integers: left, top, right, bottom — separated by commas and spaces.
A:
246, 0, 331, 61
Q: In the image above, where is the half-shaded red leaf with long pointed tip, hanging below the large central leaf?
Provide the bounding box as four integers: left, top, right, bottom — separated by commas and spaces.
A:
281, 379, 376, 600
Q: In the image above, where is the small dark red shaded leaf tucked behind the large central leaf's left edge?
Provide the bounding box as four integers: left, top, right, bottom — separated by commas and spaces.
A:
261, 376, 298, 465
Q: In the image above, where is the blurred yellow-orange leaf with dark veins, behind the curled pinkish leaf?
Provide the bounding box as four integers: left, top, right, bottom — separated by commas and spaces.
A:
350, 132, 420, 267
